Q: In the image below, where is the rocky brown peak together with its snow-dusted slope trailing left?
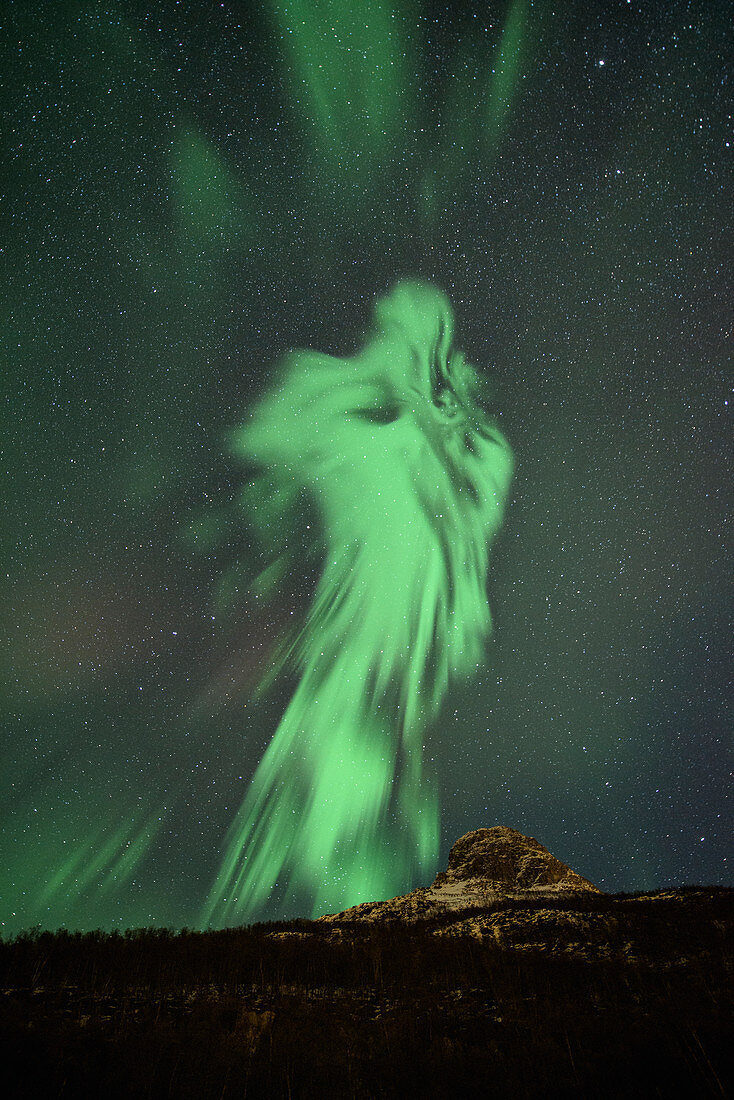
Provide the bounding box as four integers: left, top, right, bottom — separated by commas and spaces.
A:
321, 825, 601, 921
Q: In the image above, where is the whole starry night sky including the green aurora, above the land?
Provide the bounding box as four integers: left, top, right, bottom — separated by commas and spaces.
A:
0, 0, 732, 934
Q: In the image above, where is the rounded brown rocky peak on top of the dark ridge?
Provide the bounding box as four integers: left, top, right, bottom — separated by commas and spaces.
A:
432, 825, 598, 893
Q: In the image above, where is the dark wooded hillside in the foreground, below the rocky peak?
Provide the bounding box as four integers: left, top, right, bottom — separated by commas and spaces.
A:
0, 889, 734, 1100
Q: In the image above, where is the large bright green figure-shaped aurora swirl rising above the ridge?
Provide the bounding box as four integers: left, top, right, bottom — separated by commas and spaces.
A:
204, 283, 512, 923
